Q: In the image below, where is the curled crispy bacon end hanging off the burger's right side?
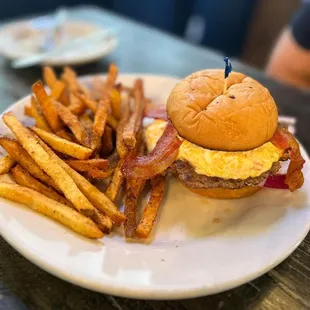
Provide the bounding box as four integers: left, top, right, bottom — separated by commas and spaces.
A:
271, 127, 305, 192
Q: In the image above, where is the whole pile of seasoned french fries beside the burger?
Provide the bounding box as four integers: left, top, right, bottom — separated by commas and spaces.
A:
0, 64, 165, 239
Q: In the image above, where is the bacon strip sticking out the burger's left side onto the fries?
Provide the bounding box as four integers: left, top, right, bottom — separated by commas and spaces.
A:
122, 122, 182, 179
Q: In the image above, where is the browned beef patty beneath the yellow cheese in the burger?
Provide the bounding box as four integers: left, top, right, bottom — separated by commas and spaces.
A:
172, 160, 281, 189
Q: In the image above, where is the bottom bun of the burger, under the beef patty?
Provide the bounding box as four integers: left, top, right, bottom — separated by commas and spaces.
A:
186, 186, 262, 199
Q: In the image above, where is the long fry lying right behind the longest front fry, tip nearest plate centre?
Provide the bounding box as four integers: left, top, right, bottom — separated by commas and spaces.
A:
39, 141, 125, 224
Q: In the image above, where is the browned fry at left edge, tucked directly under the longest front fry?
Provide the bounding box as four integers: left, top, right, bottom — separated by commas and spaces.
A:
0, 137, 60, 191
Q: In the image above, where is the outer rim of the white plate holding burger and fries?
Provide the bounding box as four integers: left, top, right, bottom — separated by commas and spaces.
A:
0, 73, 310, 300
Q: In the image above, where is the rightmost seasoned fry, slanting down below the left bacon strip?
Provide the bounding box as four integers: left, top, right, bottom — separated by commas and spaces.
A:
136, 176, 166, 238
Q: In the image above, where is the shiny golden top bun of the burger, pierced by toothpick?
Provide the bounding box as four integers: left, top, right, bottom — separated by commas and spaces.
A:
167, 70, 278, 151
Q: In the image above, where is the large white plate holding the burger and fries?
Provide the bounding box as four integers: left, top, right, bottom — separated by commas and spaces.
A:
0, 75, 310, 299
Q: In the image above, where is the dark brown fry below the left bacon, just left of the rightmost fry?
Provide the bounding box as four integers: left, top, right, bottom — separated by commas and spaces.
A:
124, 179, 145, 238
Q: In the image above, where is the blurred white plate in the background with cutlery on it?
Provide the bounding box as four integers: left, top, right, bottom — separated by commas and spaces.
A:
0, 19, 118, 66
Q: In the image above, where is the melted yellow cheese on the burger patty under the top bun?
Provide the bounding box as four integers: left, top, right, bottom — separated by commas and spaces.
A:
145, 120, 282, 180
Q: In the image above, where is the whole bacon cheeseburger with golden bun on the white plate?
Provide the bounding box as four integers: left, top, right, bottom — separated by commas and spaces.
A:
125, 70, 304, 199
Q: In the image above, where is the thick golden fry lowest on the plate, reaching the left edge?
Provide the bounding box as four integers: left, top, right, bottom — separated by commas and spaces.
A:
0, 182, 103, 239
